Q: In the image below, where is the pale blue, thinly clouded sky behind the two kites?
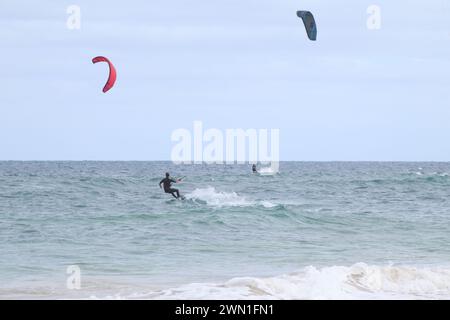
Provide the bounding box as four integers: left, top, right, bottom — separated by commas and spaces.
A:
0, 0, 450, 161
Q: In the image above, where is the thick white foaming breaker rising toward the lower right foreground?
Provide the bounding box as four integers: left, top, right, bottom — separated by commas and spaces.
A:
141, 263, 450, 300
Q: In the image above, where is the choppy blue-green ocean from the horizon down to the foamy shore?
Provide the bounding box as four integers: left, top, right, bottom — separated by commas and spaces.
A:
0, 161, 450, 299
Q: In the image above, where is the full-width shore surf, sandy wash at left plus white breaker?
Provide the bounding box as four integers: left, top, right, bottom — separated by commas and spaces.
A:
6, 263, 450, 300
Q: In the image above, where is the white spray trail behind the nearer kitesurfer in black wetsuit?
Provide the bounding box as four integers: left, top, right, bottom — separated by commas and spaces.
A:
185, 187, 279, 208
